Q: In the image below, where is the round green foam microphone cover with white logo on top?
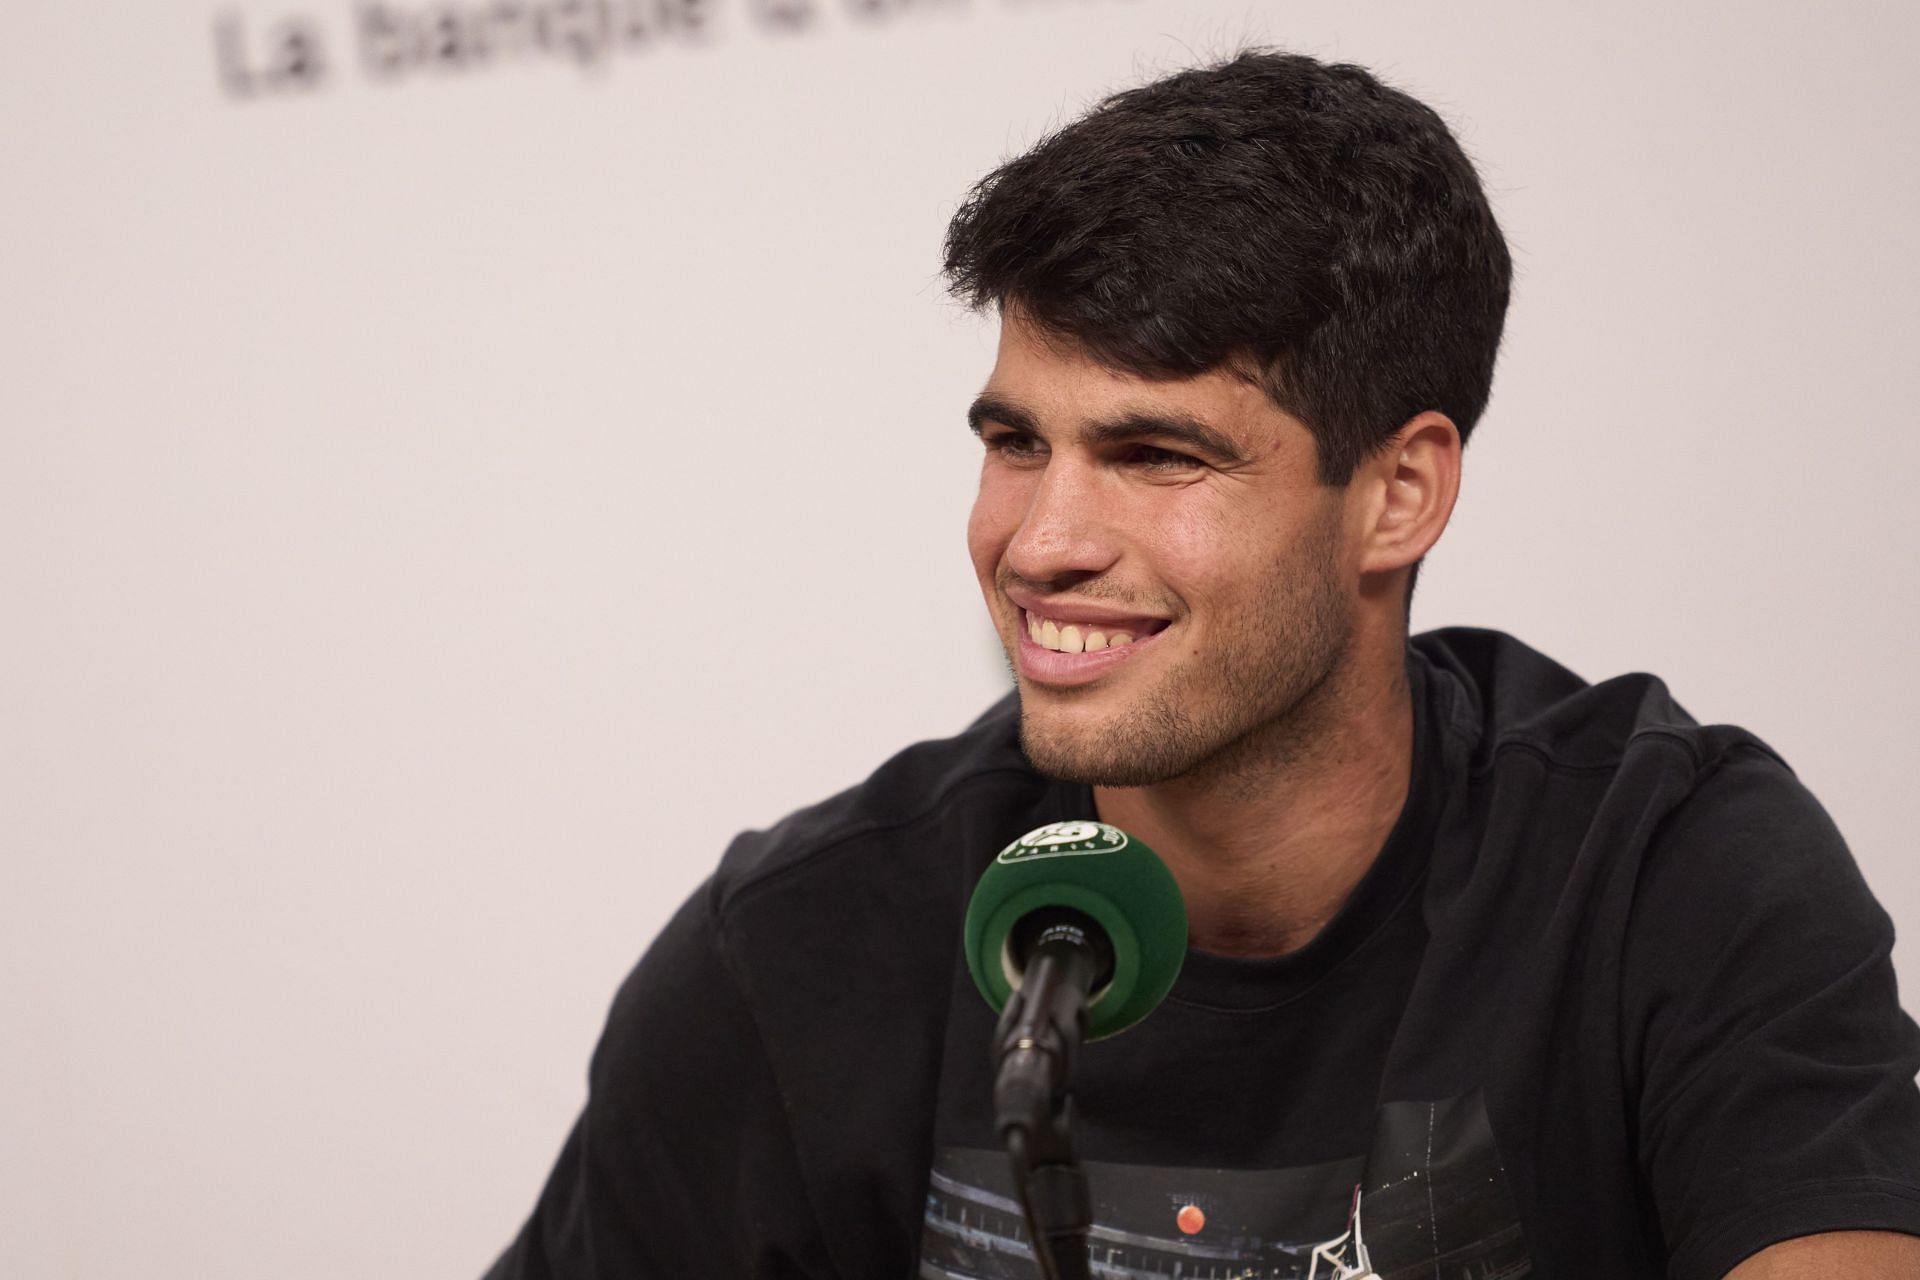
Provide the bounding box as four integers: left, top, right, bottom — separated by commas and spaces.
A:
964, 821, 1187, 1040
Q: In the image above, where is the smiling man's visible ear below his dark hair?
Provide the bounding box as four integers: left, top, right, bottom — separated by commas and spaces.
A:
1356, 411, 1459, 574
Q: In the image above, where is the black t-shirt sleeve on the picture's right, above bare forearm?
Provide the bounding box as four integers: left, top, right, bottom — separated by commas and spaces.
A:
1622, 748, 1920, 1280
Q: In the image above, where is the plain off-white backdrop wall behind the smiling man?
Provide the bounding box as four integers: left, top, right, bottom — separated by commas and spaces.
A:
0, 0, 1920, 1280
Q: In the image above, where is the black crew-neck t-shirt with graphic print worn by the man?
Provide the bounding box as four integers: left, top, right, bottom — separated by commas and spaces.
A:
492, 629, 1920, 1280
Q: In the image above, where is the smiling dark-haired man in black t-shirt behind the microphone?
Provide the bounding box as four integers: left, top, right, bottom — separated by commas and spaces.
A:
493, 54, 1920, 1280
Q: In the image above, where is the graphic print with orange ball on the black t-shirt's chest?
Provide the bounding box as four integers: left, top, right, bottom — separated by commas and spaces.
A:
920, 1094, 1534, 1280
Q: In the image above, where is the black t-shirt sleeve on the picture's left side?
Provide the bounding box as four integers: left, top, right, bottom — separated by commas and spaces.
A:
488, 890, 831, 1280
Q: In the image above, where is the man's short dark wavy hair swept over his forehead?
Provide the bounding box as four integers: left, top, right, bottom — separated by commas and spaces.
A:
945, 50, 1511, 486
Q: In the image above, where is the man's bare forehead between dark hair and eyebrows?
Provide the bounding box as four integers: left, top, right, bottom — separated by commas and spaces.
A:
983, 311, 1313, 455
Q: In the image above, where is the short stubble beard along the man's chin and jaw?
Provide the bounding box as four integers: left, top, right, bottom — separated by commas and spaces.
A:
1020, 528, 1352, 791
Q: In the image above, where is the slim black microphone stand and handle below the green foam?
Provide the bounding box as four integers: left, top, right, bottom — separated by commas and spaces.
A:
993, 938, 1098, 1280
